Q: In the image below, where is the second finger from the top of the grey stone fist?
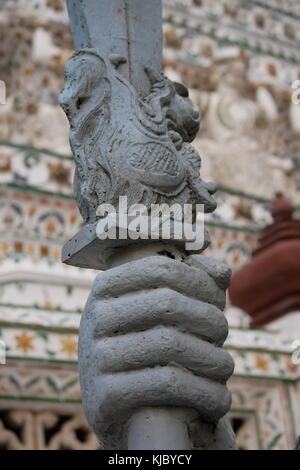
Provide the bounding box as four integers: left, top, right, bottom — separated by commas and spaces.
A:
89, 288, 228, 346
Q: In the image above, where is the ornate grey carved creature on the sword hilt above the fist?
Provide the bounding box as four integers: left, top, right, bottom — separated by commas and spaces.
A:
59, 49, 216, 223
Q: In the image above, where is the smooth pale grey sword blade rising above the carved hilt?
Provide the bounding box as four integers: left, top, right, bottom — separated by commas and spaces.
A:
67, 0, 162, 96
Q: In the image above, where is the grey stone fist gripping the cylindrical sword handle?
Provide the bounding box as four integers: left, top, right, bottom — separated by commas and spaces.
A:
79, 255, 234, 449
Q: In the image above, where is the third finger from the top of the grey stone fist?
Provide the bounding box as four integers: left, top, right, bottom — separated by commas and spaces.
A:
93, 327, 234, 383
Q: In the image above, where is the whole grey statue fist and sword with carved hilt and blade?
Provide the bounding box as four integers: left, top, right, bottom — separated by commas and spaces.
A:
59, 0, 235, 449
